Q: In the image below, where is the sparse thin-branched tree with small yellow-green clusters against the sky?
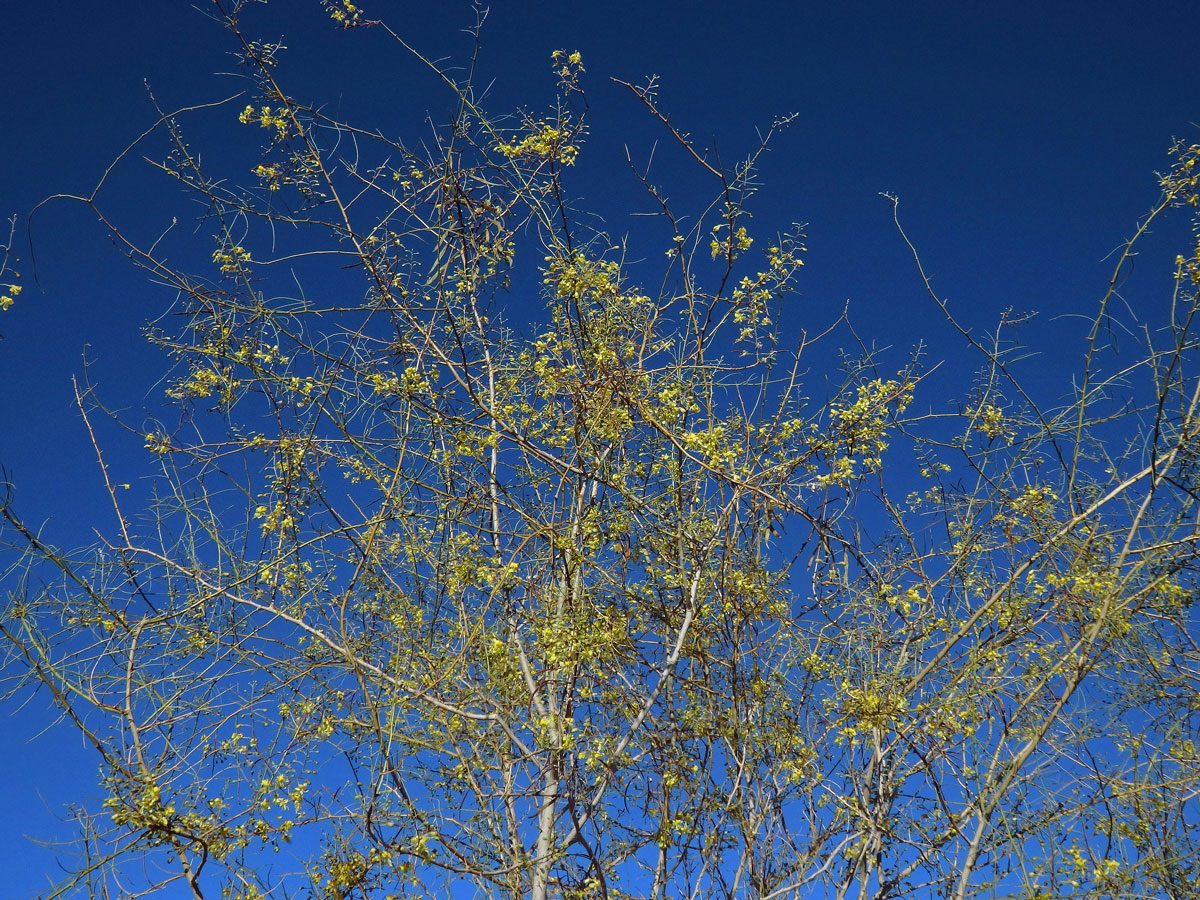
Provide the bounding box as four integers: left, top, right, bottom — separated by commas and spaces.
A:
2, 7, 1200, 900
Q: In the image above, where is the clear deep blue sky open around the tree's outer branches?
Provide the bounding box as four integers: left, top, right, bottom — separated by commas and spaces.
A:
0, 0, 1200, 896
